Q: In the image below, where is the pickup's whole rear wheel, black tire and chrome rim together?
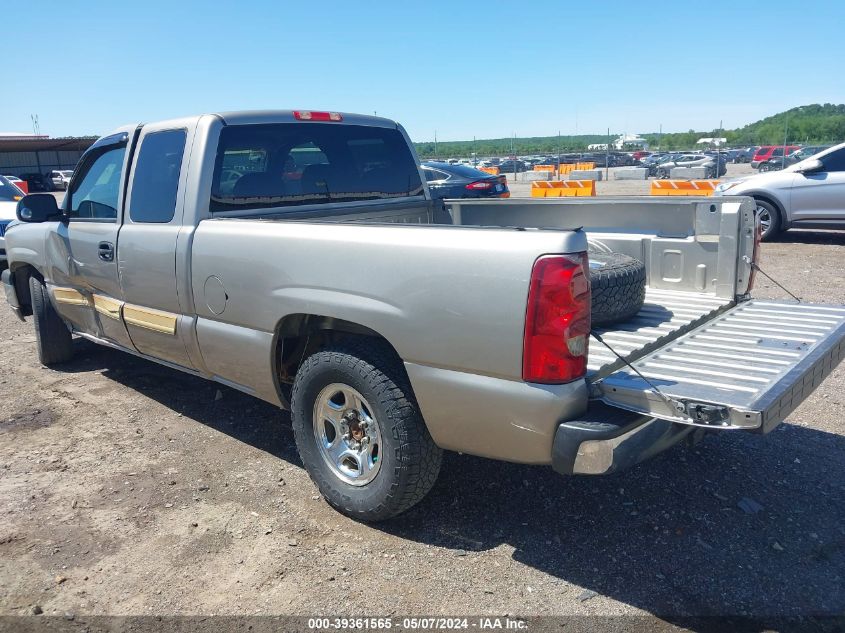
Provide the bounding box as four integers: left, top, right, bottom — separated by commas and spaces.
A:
291, 342, 442, 521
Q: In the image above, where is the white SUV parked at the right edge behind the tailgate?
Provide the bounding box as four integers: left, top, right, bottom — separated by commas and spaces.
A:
715, 143, 845, 240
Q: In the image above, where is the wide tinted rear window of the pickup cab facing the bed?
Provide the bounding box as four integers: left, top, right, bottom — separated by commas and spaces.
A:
211, 123, 423, 211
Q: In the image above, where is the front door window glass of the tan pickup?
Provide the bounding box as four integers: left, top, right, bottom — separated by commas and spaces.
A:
68, 145, 126, 221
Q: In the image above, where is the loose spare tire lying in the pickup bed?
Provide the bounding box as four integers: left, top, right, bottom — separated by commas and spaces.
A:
589, 253, 646, 325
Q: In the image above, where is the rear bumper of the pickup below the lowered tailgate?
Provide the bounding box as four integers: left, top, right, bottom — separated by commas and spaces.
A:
552, 403, 696, 475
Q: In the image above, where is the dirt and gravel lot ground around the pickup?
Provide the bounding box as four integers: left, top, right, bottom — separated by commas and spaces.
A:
0, 189, 845, 620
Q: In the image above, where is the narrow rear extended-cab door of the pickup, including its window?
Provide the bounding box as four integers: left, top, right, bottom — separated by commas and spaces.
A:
117, 120, 196, 368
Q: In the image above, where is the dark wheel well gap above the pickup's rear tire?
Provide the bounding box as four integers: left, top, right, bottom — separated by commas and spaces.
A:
273, 314, 401, 400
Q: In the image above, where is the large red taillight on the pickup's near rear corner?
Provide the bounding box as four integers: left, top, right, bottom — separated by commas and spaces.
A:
522, 253, 590, 383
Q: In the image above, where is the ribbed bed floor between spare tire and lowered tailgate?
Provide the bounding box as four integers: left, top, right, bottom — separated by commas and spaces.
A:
587, 288, 733, 380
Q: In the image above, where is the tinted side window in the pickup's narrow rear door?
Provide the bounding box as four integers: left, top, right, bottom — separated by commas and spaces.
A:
129, 130, 186, 223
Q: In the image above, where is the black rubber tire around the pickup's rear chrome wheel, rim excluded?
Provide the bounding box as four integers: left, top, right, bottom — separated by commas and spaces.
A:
291, 341, 443, 521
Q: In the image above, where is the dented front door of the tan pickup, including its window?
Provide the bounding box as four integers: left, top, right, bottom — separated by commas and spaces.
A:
45, 128, 137, 348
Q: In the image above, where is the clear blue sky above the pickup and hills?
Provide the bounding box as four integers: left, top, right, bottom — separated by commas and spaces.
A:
0, 0, 845, 141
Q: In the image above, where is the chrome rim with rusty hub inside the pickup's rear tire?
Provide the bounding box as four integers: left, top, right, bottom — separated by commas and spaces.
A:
313, 383, 382, 486
